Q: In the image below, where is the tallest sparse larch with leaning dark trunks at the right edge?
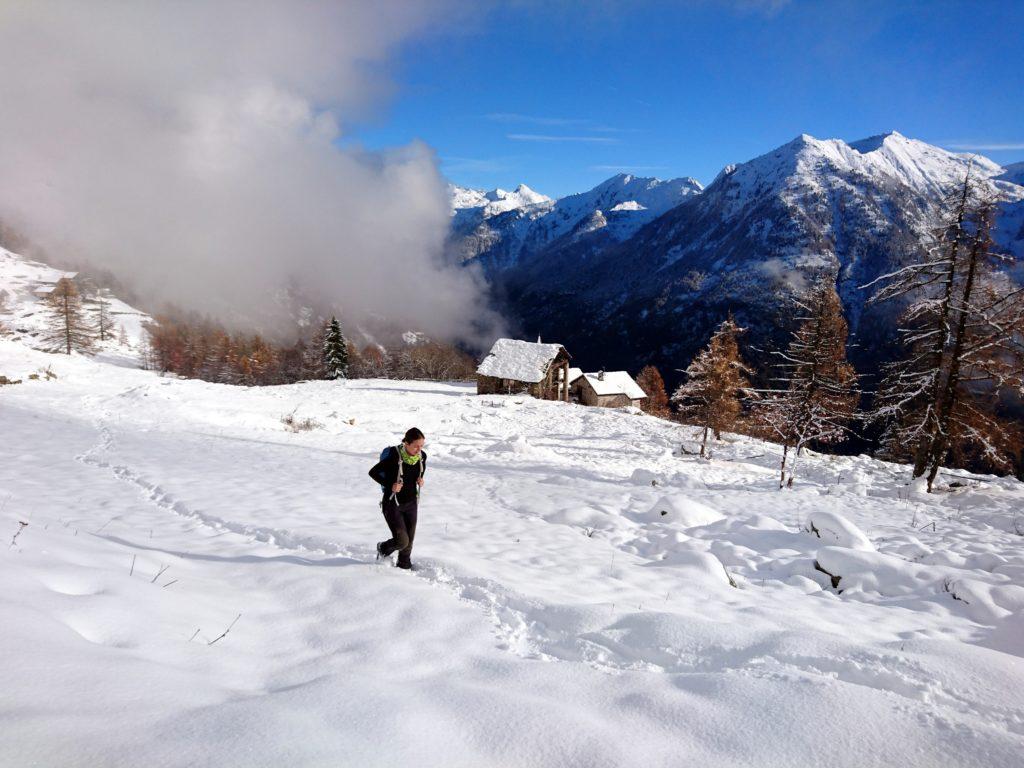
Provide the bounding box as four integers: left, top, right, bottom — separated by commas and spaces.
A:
865, 170, 1024, 492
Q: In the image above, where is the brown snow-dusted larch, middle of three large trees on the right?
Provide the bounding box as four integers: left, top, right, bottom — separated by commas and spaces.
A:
755, 280, 860, 487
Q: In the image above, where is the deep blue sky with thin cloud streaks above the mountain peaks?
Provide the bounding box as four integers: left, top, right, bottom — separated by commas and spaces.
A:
349, 0, 1024, 197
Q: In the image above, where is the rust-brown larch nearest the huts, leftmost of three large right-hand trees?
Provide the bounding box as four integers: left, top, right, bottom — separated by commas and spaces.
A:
672, 314, 751, 457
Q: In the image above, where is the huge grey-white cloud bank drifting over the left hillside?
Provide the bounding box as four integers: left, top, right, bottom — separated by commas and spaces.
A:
0, 0, 496, 337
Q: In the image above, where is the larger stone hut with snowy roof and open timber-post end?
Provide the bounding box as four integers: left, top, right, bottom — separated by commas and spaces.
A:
476, 339, 569, 402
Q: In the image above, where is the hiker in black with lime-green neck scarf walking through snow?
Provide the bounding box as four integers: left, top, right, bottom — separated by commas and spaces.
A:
370, 427, 427, 568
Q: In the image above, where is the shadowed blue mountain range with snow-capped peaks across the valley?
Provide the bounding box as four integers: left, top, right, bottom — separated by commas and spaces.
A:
453, 133, 1024, 386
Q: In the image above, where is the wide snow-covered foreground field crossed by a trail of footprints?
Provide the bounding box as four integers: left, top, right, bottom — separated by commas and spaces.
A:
0, 340, 1024, 768
